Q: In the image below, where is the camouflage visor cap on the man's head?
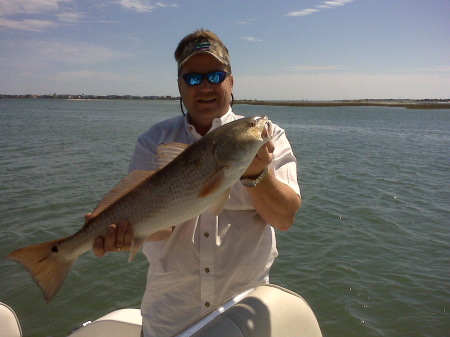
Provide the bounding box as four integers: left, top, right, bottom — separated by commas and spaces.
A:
177, 39, 231, 70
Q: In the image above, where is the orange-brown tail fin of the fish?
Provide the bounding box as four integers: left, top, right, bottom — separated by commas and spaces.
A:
7, 239, 77, 302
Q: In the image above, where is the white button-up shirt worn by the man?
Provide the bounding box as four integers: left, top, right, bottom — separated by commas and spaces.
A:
130, 108, 300, 337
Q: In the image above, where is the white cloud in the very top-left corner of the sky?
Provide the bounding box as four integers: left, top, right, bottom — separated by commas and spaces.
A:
0, 0, 66, 16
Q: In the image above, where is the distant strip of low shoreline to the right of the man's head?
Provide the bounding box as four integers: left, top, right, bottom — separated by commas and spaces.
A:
234, 100, 450, 109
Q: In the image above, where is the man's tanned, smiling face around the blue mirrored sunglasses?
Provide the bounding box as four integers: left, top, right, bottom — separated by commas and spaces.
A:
178, 54, 233, 133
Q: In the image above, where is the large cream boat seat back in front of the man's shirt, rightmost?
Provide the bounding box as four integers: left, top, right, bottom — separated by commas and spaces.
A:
188, 285, 322, 337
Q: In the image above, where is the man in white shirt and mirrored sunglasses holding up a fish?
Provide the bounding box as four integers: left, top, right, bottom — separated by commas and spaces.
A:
94, 29, 300, 336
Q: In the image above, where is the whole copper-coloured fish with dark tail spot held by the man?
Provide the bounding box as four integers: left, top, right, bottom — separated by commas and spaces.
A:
7, 116, 270, 302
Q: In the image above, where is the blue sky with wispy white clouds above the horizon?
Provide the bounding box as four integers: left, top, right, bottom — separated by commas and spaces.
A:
0, 0, 450, 100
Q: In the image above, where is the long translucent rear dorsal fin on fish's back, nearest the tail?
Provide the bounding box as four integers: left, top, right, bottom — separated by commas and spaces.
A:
89, 170, 155, 220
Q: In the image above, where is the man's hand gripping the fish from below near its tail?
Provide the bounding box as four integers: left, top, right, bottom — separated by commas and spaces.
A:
85, 213, 133, 257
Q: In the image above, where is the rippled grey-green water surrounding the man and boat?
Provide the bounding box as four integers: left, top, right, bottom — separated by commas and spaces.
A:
0, 100, 450, 337
